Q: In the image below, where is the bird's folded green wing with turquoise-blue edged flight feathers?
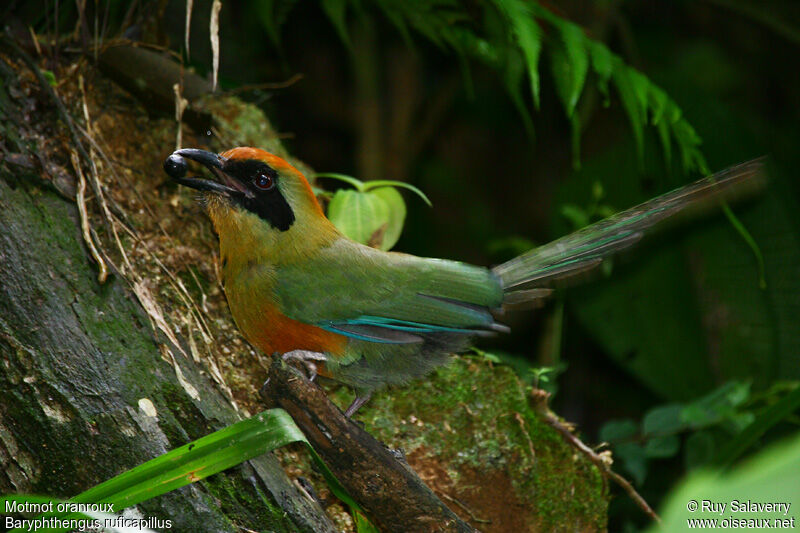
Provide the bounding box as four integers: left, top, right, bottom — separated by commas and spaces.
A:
276, 238, 504, 344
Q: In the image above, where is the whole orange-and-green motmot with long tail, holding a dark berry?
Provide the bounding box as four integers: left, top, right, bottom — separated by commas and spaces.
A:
163, 147, 764, 417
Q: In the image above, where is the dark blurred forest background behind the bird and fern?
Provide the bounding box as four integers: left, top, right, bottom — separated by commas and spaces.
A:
9, 0, 800, 530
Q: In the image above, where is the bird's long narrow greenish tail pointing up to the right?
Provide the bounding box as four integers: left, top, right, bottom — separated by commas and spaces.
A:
493, 159, 766, 305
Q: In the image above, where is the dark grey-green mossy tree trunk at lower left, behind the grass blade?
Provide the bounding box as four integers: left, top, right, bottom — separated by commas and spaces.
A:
0, 40, 335, 532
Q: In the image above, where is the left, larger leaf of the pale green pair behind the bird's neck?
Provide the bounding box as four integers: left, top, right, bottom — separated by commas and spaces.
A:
328, 189, 389, 245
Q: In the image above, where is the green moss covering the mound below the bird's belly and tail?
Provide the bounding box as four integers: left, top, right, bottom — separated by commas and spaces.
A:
338, 357, 608, 530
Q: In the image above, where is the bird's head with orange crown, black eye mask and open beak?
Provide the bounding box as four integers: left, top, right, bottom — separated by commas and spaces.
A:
164, 147, 337, 260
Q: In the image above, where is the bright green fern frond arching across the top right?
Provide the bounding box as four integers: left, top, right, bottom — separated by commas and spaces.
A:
259, 0, 706, 172
